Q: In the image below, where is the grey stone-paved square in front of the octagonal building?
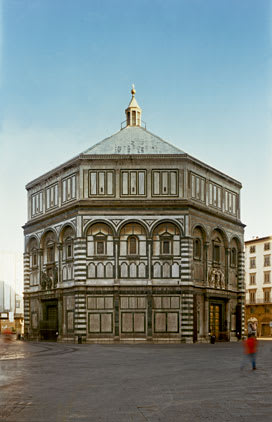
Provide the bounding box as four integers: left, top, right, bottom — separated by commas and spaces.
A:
0, 340, 272, 422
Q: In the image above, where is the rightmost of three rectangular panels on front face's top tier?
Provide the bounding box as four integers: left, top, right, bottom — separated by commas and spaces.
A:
152, 170, 178, 196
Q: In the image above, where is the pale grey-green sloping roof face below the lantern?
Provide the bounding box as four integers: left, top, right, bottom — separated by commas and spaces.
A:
83, 126, 185, 155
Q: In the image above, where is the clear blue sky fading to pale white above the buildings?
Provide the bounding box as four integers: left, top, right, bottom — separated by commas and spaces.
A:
0, 0, 272, 290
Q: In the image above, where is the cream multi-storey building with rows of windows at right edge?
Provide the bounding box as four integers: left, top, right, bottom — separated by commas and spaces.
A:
245, 236, 272, 337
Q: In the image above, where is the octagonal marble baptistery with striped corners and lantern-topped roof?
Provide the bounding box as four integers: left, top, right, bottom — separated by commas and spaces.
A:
23, 89, 244, 343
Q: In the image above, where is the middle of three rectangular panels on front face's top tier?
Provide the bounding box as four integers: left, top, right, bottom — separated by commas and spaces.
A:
121, 170, 146, 196
